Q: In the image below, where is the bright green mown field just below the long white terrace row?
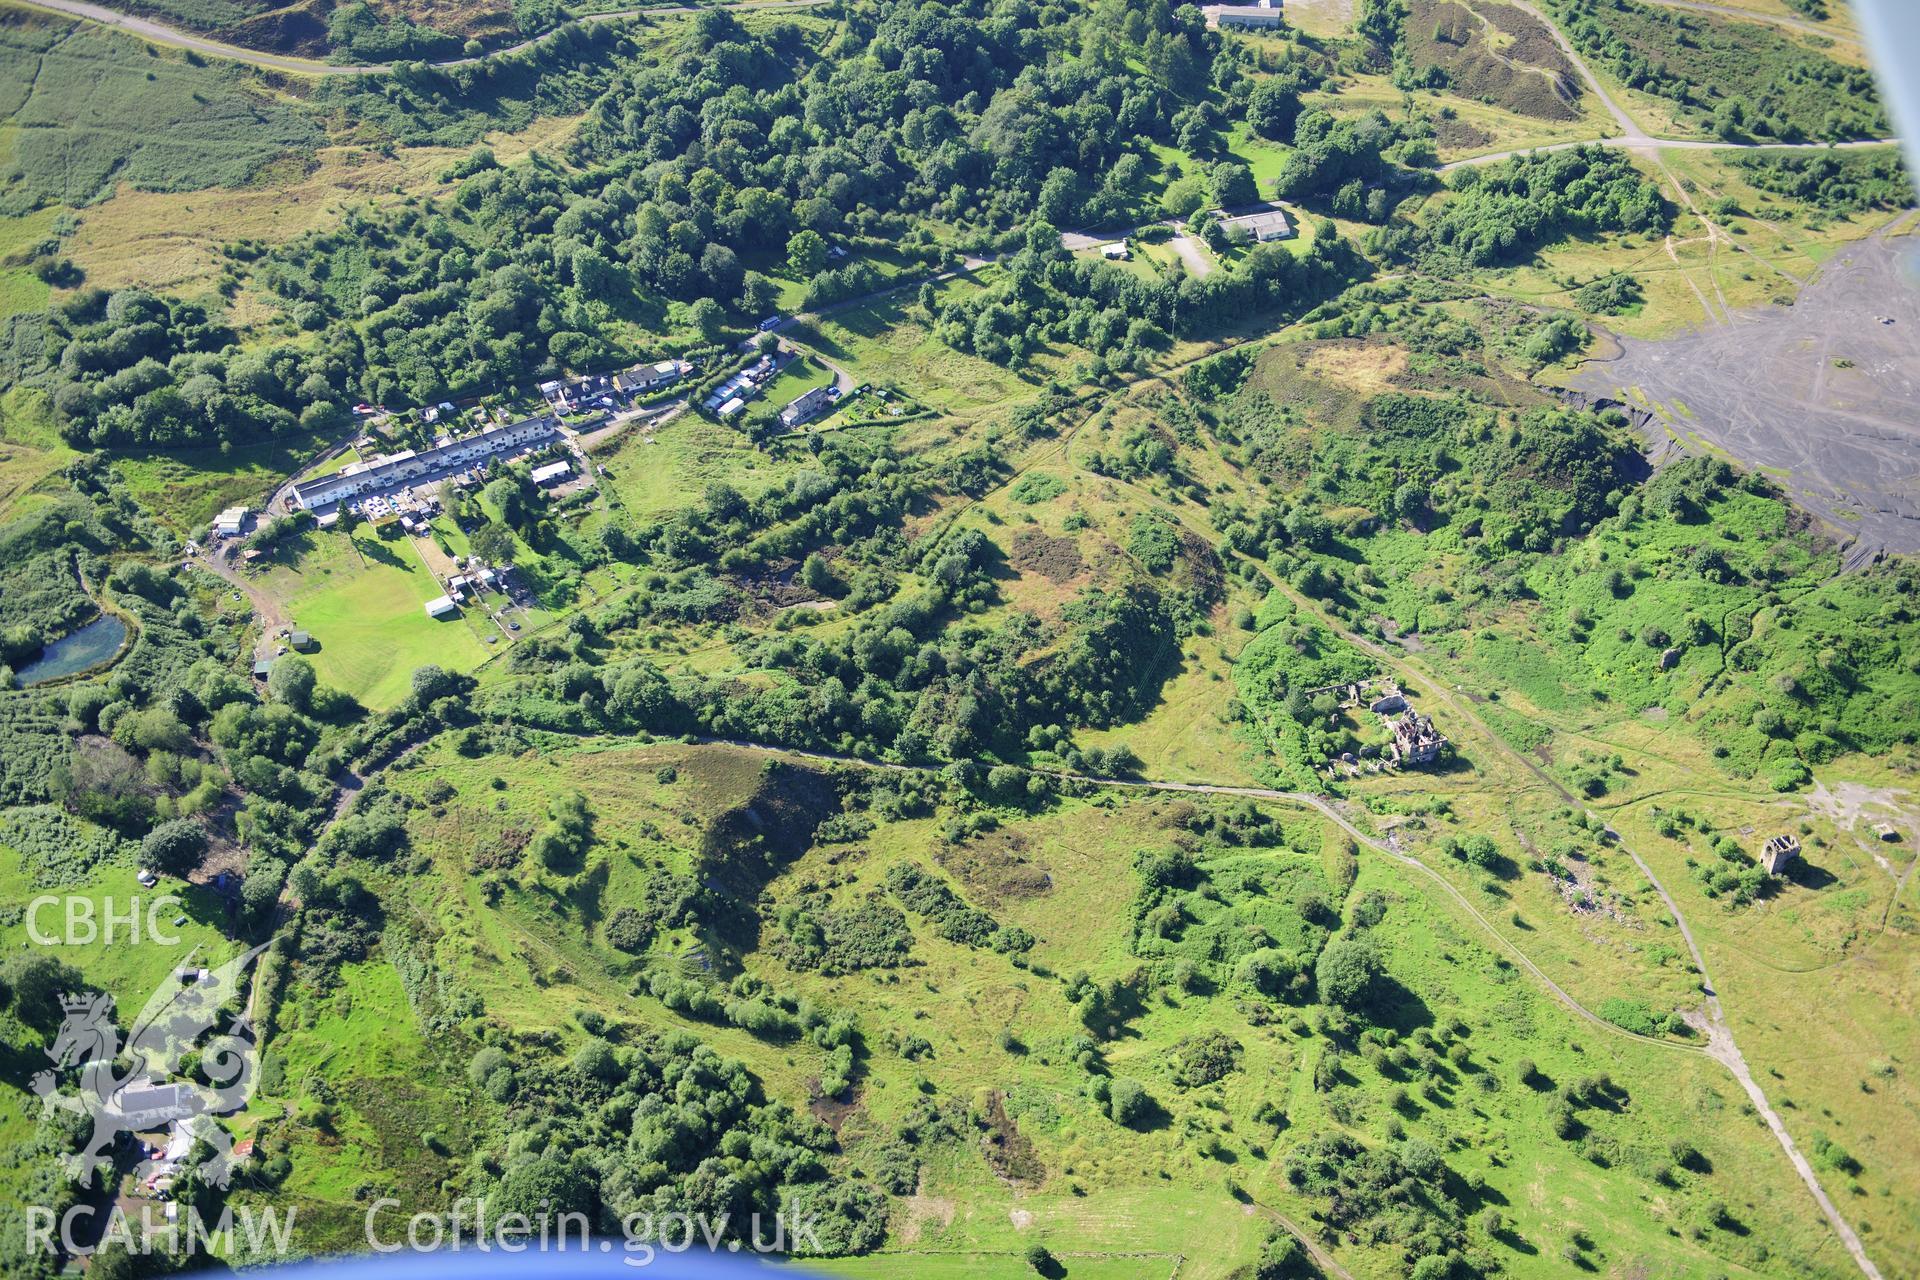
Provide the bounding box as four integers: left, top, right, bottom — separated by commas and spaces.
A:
259, 528, 493, 710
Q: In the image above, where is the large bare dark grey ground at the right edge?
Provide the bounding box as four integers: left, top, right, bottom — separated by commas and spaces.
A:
1572, 218, 1920, 562
